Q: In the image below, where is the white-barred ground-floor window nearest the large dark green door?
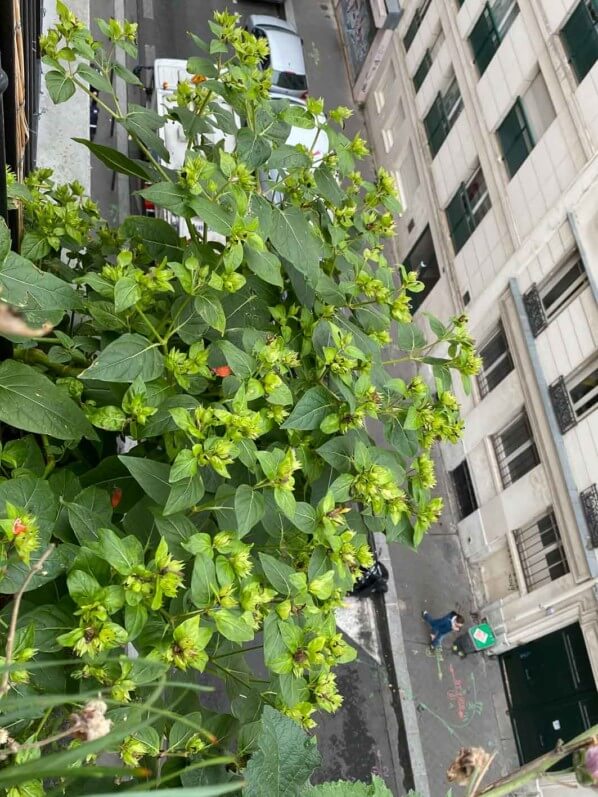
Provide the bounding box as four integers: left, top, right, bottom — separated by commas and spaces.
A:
515, 511, 569, 590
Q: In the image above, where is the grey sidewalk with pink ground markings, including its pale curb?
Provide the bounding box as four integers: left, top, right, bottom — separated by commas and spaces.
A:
383, 450, 518, 797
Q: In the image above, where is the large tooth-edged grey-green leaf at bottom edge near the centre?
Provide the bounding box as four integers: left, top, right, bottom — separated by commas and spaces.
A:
243, 706, 321, 797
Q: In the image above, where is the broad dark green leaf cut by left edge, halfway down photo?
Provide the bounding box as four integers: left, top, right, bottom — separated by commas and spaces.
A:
0, 360, 96, 440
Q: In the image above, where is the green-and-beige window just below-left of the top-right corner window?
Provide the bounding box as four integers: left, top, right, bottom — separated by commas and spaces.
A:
497, 71, 555, 177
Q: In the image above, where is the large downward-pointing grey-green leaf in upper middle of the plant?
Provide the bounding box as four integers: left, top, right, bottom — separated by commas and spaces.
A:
270, 206, 323, 288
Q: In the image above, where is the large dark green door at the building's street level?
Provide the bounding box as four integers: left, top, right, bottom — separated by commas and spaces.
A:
500, 623, 598, 764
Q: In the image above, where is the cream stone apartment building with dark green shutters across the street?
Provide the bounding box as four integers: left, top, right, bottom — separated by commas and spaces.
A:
365, 0, 598, 761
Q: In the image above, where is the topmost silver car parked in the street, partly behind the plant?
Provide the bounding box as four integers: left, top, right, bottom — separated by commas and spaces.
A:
246, 14, 307, 98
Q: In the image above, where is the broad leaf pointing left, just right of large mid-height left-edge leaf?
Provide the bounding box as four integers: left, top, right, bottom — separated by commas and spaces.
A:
79, 333, 164, 384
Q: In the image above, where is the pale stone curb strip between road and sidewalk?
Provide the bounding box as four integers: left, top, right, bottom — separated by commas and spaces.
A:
374, 534, 430, 797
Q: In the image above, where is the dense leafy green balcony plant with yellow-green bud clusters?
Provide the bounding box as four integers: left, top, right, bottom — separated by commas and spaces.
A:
0, 2, 479, 797
